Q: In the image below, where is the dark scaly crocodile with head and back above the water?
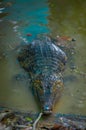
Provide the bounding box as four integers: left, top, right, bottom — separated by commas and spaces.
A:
18, 37, 67, 114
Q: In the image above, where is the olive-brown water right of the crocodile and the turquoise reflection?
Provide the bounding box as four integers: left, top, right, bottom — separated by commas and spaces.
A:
48, 0, 86, 114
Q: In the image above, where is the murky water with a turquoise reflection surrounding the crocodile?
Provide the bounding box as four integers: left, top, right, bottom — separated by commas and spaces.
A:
0, 0, 86, 115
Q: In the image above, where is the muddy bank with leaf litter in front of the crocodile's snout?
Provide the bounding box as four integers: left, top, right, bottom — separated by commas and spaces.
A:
0, 107, 86, 130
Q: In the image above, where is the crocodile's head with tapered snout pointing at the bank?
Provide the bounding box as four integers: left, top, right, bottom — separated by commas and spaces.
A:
33, 74, 63, 114
